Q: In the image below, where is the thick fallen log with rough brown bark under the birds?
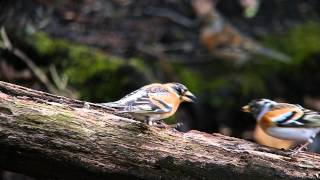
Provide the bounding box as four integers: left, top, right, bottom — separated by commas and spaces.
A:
0, 82, 320, 179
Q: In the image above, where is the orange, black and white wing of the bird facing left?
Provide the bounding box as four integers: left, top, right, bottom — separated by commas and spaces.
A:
265, 103, 320, 128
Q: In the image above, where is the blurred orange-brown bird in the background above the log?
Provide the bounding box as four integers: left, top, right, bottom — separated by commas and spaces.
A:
193, 0, 290, 64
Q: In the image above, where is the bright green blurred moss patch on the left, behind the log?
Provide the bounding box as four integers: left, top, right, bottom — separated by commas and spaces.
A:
26, 32, 124, 83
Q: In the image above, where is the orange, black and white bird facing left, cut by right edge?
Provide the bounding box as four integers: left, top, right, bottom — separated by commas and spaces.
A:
242, 99, 320, 155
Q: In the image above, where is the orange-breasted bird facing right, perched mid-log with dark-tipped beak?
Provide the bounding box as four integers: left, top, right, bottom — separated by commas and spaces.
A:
102, 83, 196, 125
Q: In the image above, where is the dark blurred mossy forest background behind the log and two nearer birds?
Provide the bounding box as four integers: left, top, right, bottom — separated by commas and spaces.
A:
0, 0, 320, 180
